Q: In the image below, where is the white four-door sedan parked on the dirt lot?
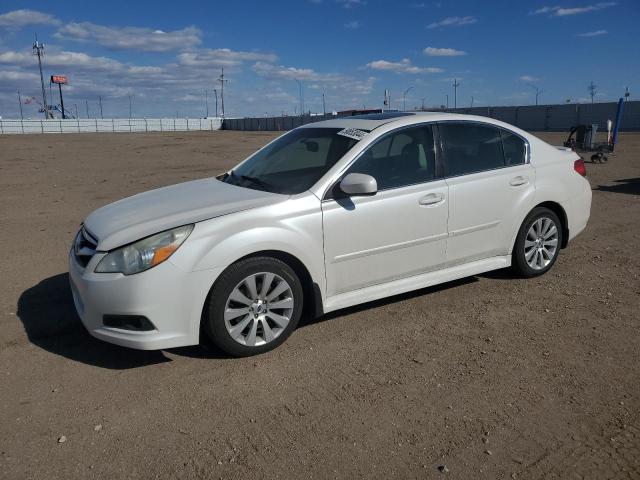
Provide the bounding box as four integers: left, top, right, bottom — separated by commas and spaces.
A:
69, 113, 591, 356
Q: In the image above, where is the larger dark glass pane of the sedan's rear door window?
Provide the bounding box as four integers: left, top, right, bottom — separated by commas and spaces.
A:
438, 123, 505, 177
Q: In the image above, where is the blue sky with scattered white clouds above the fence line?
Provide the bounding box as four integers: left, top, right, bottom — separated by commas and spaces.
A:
0, 0, 640, 118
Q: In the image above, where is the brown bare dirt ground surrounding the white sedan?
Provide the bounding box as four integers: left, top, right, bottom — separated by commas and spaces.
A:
0, 132, 640, 479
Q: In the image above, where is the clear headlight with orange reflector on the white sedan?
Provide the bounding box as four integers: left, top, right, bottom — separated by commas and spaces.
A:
96, 225, 193, 275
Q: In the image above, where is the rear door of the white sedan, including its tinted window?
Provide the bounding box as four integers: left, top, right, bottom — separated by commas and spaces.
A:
437, 122, 535, 265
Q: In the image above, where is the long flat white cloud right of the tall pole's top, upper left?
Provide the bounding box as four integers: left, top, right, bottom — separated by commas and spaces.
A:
54, 22, 202, 52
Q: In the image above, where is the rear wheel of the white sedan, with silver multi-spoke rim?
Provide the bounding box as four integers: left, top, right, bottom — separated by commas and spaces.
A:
511, 207, 563, 278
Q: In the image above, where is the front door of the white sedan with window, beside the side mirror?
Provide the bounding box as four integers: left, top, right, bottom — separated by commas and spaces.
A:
322, 124, 448, 297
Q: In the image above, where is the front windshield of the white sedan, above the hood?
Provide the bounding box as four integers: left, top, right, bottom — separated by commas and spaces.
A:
221, 128, 358, 195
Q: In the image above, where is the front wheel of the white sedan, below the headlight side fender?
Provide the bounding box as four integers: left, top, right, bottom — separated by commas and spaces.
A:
203, 257, 303, 357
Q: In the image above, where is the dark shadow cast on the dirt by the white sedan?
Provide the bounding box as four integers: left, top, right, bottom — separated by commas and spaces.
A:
17, 273, 478, 370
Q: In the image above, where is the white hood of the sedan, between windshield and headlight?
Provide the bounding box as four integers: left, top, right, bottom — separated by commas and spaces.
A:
84, 178, 289, 251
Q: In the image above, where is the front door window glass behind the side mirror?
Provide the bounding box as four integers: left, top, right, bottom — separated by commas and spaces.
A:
347, 125, 436, 190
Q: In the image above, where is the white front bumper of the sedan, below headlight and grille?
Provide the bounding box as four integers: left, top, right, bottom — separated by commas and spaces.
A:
69, 250, 218, 350
